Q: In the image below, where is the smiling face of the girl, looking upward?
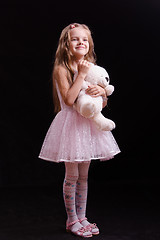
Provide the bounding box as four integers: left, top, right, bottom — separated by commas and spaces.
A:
69, 27, 89, 60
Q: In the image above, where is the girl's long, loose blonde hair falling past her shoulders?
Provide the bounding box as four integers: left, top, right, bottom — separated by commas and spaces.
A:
52, 23, 96, 112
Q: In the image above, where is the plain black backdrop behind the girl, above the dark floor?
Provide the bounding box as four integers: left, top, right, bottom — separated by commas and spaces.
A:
0, 0, 160, 186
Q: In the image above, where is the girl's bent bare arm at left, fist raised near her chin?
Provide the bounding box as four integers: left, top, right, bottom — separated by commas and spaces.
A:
54, 60, 90, 106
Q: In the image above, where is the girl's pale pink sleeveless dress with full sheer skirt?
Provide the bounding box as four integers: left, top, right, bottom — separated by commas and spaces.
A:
39, 82, 120, 163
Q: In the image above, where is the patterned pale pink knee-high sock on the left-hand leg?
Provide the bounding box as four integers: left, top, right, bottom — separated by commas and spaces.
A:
63, 175, 78, 222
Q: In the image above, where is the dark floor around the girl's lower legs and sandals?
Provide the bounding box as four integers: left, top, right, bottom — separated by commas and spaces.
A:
0, 181, 160, 240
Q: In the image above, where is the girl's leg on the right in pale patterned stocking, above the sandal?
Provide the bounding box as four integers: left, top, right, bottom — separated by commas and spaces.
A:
76, 162, 90, 226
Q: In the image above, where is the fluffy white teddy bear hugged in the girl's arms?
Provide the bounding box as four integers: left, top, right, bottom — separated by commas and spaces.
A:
74, 64, 115, 131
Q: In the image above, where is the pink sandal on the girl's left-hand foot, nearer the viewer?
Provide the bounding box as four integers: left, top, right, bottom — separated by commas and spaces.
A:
66, 220, 92, 238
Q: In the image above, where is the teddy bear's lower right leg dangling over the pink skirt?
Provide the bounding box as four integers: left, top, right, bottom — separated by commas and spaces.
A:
92, 113, 115, 131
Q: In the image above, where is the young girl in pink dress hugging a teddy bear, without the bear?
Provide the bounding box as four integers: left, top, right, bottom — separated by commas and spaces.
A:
39, 23, 120, 237
